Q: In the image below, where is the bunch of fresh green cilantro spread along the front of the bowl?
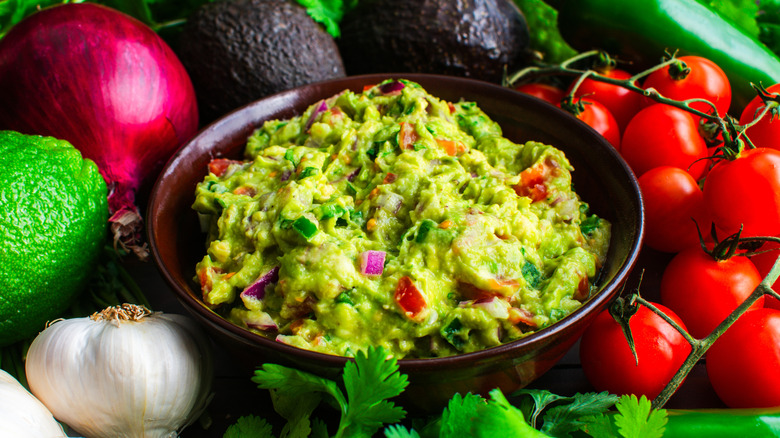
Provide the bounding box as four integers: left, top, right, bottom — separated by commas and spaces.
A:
223, 348, 668, 438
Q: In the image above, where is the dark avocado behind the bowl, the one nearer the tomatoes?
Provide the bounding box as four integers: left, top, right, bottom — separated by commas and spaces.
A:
337, 0, 528, 82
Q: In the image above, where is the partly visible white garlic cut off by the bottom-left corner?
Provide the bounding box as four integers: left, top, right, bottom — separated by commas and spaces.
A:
0, 370, 67, 438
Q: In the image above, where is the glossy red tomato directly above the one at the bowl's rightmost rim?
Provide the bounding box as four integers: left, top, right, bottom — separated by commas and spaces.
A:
620, 103, 707, 179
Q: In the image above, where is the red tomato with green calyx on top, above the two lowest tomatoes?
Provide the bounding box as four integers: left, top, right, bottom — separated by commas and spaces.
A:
661, 248, 764, 338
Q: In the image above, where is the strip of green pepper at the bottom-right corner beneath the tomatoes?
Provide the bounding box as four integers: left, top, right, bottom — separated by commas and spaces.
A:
664, 408, 780, 438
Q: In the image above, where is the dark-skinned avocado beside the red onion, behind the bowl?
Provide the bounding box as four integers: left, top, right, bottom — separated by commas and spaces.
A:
177, 0, 345, 123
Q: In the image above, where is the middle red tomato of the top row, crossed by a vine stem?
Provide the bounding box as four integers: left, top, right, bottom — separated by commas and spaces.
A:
569, 69, 643, 132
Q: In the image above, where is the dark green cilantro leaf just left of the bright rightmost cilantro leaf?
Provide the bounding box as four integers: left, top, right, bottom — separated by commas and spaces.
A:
541, 392, 618, 436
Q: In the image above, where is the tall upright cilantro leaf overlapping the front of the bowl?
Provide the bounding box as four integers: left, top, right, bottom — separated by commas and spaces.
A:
336, 347, 409, 437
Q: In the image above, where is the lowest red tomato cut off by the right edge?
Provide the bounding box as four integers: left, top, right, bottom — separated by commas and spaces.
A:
706, 308, 780, 408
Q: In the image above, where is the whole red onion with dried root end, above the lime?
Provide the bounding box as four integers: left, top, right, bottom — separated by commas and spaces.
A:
0, 3, 198, 257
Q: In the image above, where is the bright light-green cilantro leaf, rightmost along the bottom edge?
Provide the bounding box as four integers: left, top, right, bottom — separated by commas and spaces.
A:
615, 395, 668, 438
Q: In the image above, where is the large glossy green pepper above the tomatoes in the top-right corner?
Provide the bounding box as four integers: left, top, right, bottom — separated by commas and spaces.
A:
548, 0, 780, 114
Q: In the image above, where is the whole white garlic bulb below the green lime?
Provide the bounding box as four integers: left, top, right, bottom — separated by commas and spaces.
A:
25, 304, 213, 438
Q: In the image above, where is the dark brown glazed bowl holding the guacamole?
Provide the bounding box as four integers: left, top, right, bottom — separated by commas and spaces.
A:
147, 74, 644, 412
